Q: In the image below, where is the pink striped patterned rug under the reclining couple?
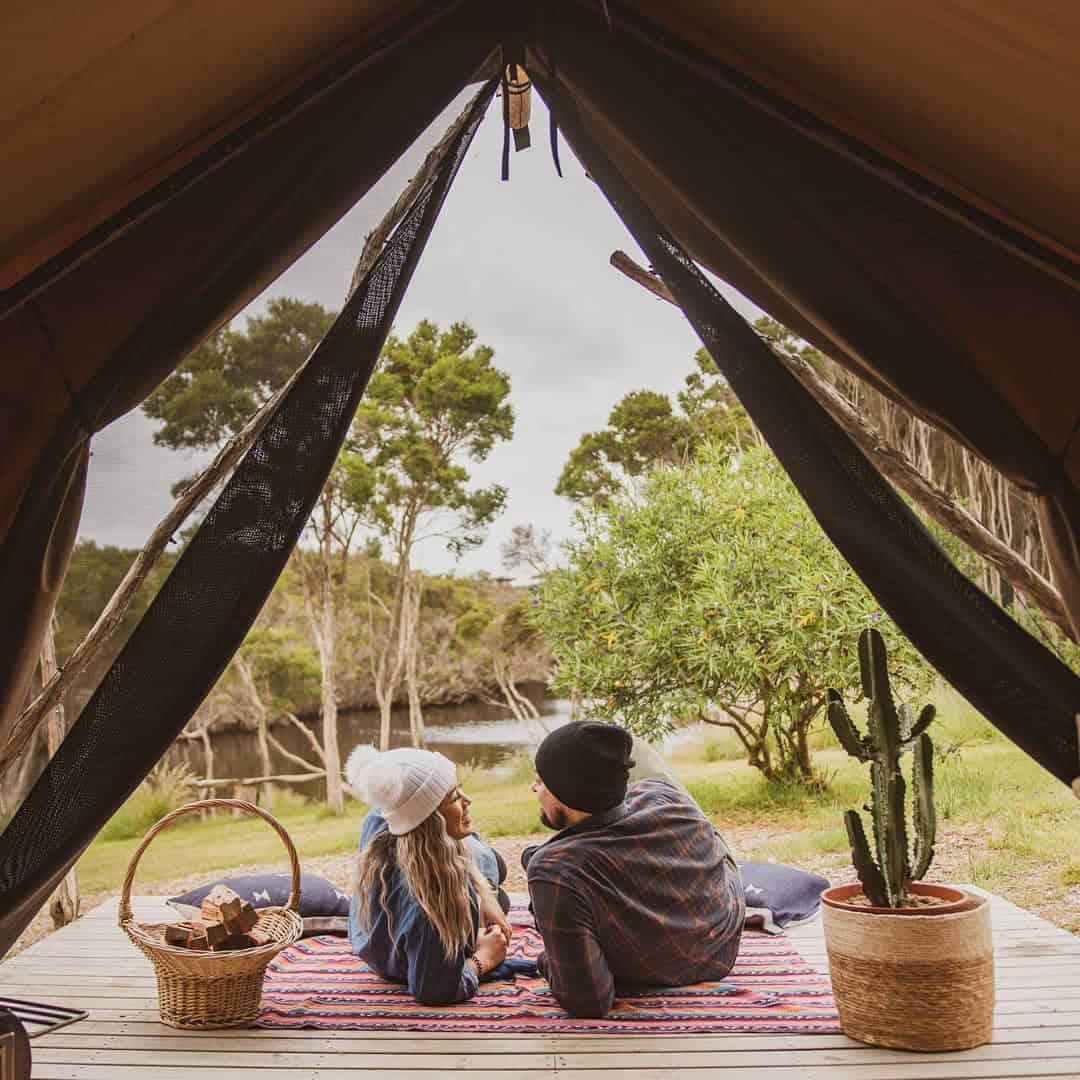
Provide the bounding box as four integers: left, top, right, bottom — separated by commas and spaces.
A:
257, 908, 840, 1035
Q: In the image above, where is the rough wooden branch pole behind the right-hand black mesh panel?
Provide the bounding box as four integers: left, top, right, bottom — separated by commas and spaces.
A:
610, 252, 1076, 640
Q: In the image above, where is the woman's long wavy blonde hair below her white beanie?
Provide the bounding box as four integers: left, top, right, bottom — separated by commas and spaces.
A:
356, 810, 477, 959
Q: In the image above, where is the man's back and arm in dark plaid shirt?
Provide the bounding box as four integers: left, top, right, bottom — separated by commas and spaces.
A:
528, 779, 744, 1015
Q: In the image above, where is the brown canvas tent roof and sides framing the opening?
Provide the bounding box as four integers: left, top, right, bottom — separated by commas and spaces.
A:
0, 0, 1080, 946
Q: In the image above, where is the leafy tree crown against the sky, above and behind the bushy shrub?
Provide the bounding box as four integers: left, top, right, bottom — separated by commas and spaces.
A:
555, 349, 754, 504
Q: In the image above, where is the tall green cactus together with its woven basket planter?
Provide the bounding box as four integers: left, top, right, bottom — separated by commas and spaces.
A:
822, 630, 994, 1051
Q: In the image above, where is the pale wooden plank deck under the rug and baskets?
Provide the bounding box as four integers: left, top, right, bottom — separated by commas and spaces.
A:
0, 897, 1080, 1080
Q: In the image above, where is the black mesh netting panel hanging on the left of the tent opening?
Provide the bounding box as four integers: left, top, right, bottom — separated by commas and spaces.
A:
0, 81, 496, 956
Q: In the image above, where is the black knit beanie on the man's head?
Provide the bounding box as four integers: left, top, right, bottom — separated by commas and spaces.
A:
536, 720, 634, 813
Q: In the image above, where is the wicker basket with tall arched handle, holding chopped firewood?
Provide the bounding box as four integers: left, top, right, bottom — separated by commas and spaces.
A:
120, 799, 303, 1028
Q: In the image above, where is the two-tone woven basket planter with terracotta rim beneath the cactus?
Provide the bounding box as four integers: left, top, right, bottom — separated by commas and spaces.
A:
822, 886, 994, 1051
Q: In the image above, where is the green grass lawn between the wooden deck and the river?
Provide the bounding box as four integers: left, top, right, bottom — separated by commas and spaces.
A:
79, 690, 1080, 932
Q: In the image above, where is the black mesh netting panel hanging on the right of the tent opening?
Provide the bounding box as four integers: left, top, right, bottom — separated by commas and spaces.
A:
548, 79, 1080, 784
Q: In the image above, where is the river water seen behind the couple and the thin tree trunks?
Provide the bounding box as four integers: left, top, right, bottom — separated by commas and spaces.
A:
170, 686, 570, 799
